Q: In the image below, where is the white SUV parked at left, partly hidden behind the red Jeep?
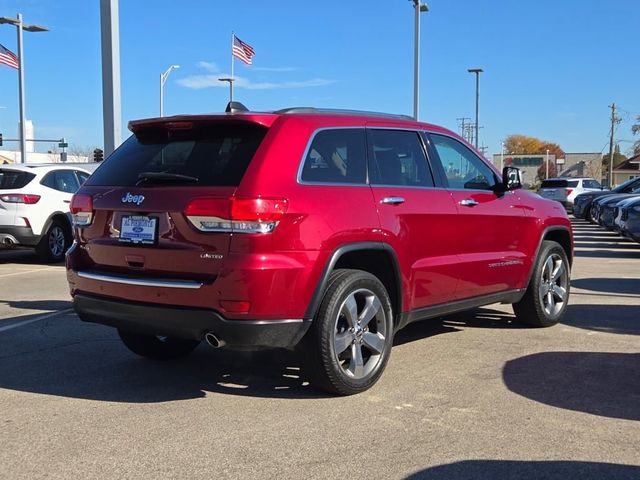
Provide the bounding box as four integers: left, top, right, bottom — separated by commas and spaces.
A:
0, 164, 95, 262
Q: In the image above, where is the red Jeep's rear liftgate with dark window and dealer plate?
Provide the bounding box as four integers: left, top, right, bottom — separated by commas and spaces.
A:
72, 119, 267, 283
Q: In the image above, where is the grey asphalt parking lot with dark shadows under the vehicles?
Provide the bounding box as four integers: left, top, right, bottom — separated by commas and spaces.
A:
0, 221, 640, 479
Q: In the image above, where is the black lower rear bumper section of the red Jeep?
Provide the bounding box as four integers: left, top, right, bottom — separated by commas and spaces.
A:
73, 295, 311, 348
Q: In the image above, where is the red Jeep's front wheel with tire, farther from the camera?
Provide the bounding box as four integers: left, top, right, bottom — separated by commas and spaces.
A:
513, 240, 570, 327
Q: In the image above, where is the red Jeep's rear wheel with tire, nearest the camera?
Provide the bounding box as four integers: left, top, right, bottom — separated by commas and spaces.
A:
311, 269, 393, 395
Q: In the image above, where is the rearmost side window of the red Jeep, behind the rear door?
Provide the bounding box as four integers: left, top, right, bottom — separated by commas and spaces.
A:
300, 128, 366, 183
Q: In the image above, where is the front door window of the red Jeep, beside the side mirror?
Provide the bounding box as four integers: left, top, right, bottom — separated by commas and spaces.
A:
431, 134, 496, 190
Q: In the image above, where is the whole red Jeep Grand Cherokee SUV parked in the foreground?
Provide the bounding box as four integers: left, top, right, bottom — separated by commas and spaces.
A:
67, 107, 573, 395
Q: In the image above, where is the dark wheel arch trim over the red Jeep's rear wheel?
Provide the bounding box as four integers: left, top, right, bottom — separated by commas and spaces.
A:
304, 242, 402, 318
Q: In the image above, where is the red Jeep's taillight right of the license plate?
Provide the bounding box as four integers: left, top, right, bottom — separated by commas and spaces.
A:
184, 197, 289, 233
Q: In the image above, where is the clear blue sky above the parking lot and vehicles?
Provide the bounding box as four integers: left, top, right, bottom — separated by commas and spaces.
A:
0, 0, 640, 153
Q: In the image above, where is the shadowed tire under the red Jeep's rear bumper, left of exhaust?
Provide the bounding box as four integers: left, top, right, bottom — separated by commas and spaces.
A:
118, 329, 200, 360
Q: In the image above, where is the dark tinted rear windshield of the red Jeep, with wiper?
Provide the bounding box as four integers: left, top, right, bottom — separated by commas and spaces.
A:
85, 124, 267, 187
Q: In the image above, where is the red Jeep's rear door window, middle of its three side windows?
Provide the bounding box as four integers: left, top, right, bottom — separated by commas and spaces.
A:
369, 129, 434, 187
